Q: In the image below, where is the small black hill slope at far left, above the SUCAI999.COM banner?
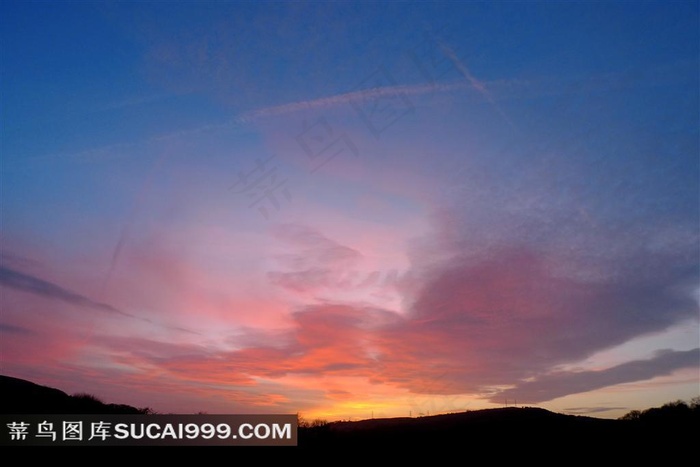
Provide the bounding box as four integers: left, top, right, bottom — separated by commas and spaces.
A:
0, 375, 150, 414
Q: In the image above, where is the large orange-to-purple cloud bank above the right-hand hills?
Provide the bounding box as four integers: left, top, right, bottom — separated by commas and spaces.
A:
104, 241, 698, 402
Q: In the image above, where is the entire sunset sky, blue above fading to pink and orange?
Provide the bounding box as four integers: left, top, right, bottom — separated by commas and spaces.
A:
0, 1, 700, 420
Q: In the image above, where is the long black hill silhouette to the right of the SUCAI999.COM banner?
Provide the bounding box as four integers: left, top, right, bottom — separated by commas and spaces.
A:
299, 402, 700, 450
